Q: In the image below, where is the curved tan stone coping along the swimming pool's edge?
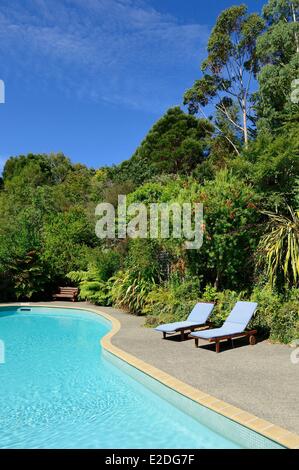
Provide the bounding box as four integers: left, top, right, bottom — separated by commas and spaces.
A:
0, 302, 299, 449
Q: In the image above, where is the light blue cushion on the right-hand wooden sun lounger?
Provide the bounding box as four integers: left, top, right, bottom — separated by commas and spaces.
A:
192, 302, 258, 339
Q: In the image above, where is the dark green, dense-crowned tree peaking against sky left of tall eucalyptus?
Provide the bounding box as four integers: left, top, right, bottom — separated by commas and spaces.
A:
105, 107, 213, 184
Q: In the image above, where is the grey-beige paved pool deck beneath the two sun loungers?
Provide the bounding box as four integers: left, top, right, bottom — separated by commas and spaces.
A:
5, 302, 299, 434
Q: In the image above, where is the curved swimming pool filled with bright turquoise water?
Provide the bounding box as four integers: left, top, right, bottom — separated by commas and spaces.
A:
0, 307, 279, 449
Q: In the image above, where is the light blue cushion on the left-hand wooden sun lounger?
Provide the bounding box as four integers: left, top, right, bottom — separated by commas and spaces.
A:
155, 303, 214, 333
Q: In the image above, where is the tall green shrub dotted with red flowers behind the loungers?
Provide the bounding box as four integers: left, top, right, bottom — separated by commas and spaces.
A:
192, 170, 260, 289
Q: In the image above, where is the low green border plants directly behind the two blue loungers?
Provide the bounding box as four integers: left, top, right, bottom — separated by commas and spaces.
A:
143, 279, 299, 343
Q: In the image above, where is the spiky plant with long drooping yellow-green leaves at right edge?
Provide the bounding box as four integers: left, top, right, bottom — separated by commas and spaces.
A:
258, 207, 299, 286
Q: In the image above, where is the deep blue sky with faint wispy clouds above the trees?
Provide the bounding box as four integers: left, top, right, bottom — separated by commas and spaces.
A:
0, 0, 265, 173
